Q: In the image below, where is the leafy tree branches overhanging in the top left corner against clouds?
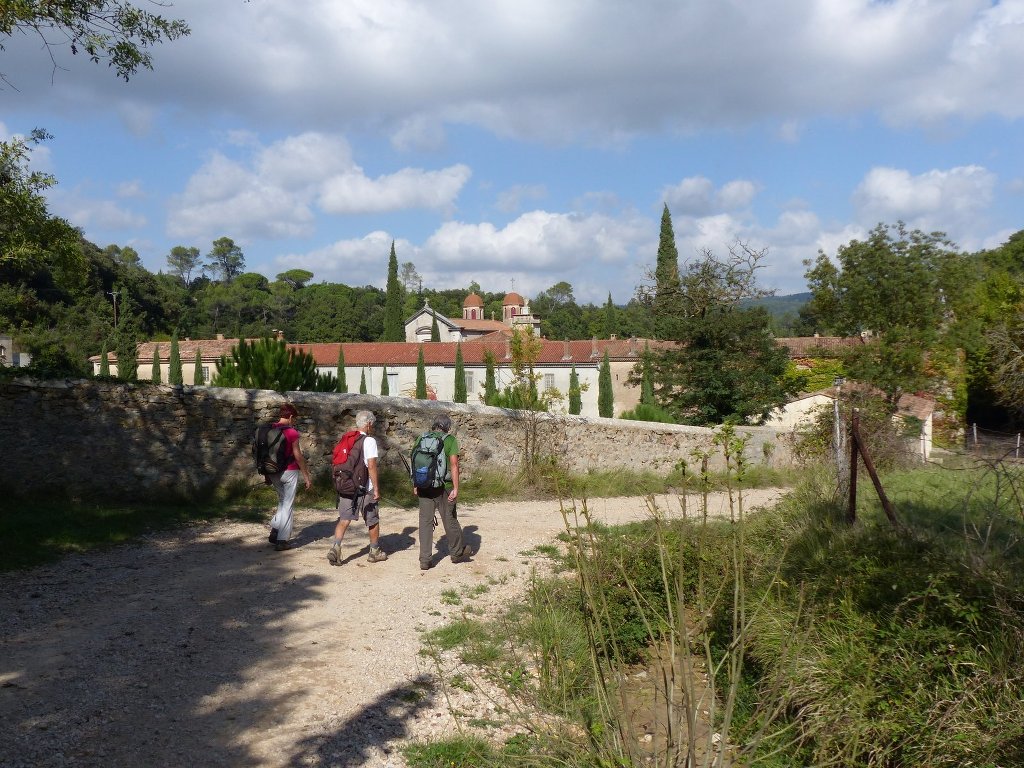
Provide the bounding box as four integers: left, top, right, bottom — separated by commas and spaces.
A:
0, 0, 189, 81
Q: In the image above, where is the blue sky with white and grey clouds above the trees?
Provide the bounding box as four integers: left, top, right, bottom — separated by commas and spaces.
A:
0, 0, 1024, 304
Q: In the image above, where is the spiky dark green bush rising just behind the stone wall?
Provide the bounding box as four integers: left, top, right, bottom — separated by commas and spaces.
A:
212, 338, 317, 392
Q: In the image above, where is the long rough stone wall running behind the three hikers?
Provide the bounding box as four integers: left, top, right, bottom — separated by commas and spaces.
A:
0, 379, 792, 499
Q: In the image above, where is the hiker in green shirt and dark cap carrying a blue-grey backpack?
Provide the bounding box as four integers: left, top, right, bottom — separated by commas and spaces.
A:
413, 415, 473, 570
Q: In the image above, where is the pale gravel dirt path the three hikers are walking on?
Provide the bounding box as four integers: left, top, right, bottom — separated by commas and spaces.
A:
0, 489, 780, 768
